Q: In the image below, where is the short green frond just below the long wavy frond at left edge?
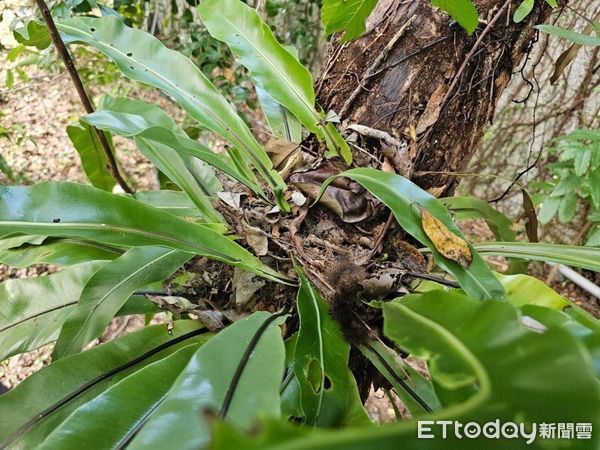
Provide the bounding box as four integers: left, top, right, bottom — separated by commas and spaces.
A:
0, 239, 123, 267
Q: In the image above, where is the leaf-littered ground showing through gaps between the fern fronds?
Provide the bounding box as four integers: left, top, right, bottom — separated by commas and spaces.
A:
0, 5, 600, 421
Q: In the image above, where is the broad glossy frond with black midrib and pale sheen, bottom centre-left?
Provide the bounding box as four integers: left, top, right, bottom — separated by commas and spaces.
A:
128, 312, 285, 450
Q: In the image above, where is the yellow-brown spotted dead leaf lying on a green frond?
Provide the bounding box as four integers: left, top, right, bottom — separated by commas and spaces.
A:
419, 207, 473, 268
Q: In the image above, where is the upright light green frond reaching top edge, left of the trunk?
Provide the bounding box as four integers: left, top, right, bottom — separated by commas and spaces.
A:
198, 0, 352, 163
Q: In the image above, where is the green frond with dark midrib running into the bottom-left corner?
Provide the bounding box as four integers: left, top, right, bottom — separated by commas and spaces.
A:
0, 321, 206, 449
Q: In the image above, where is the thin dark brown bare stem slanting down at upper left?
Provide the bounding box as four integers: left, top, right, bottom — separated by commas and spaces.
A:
35, 0, 133, 194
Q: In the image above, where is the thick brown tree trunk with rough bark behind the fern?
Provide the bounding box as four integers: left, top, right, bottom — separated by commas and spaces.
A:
317, 0, 551, 196
